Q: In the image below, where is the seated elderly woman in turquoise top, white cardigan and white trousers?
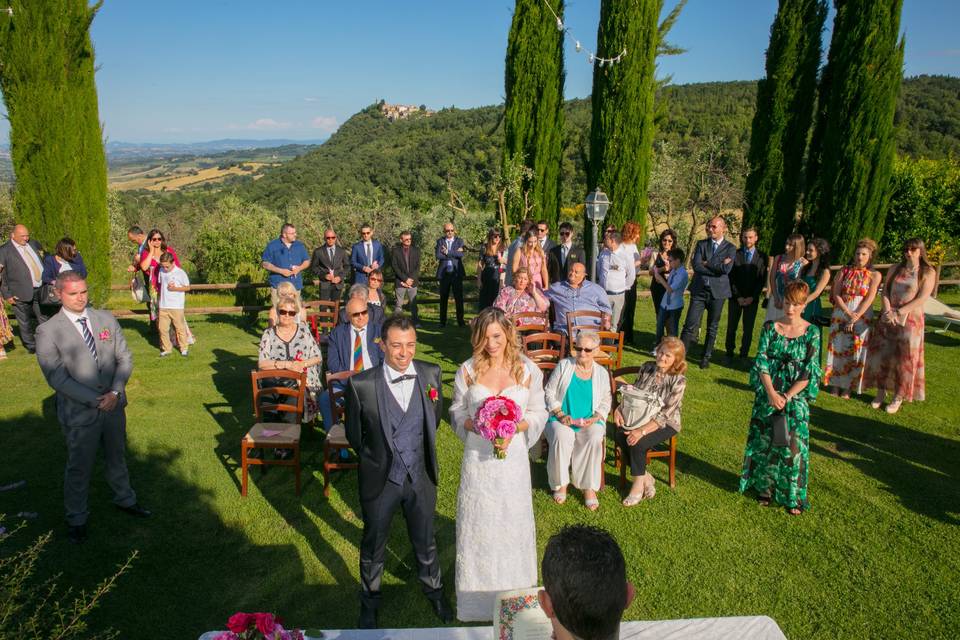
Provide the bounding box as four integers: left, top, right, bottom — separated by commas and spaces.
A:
545, 331, 612, 511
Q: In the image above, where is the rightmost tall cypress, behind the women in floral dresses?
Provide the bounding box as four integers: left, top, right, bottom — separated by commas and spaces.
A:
803, 0, 903, 260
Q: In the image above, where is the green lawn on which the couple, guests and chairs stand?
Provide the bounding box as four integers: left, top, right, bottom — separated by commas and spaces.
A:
0, 295, 960, 639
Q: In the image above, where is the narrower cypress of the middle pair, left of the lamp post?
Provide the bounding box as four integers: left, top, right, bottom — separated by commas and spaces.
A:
503, 0, 564, 228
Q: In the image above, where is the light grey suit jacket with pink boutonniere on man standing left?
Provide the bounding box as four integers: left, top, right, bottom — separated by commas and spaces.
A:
37, 307, 133, 427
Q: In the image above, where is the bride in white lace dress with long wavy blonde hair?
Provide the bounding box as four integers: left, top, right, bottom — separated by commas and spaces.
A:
450, 307, 547, 622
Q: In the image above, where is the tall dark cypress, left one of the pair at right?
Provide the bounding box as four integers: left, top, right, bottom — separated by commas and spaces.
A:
743, 0, 827, 252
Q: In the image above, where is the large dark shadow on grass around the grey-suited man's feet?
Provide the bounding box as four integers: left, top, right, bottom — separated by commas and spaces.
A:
0, 394, 316, 638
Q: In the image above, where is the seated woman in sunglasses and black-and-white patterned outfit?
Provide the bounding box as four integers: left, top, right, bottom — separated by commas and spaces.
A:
257, 296, 323, 422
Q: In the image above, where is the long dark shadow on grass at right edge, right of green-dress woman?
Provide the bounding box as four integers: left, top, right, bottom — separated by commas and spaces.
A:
810, 405, 960, 525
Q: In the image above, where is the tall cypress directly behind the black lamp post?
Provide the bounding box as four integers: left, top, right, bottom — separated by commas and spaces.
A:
586, 0, 663, 242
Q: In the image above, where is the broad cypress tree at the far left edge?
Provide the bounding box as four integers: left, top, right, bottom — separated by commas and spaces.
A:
0, 0, 110, 302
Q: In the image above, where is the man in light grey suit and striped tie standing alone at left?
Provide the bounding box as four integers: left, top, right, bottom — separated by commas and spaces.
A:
37, 271, 150, 544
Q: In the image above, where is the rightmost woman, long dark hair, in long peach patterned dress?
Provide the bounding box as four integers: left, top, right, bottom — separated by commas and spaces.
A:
863, 238, 937, 413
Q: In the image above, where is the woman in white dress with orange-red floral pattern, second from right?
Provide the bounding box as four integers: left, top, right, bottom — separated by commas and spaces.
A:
823, 238, 881, 399
